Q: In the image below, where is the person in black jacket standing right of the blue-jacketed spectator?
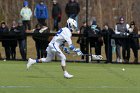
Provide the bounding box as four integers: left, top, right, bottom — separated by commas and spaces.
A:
52, 0, 61, 31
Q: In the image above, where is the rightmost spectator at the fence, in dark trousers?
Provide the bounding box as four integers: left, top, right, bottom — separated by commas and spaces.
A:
129, 21, 139, 63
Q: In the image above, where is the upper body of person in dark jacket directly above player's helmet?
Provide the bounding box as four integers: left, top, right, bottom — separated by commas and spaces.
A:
65, 0, 80, 19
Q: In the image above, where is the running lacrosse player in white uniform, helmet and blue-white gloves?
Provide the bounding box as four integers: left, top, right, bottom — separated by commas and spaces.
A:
27, 18, 83, 78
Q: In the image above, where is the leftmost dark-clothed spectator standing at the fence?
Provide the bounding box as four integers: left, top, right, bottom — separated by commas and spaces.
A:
0, 22, 10, 60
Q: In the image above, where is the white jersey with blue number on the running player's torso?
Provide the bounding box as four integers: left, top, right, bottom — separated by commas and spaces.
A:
47, 27, 72, 52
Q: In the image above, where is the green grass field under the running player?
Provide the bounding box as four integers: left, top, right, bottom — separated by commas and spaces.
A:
0, 61, 140, 93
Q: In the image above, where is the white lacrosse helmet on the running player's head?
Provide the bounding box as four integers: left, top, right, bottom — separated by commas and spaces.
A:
67, 18, 77, 31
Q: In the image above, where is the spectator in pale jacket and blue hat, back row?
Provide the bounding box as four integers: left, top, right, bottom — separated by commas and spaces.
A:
20, 0, 32, 31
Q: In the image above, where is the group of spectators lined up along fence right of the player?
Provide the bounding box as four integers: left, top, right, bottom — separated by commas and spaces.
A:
77, 17, 140, 63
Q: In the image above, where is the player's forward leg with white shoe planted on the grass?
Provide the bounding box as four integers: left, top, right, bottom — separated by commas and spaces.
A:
57, 52, 73, 78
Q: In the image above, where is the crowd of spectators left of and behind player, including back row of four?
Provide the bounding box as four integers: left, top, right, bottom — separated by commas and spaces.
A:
0, 0, 80, 60
